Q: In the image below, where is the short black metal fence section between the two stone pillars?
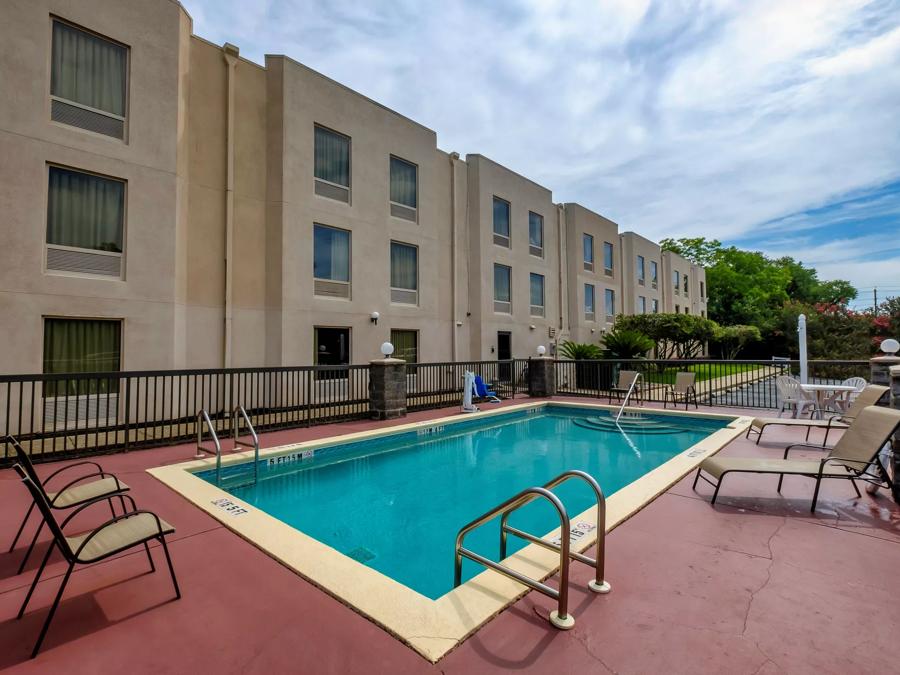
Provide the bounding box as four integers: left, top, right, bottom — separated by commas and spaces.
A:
406, 359, 528, 411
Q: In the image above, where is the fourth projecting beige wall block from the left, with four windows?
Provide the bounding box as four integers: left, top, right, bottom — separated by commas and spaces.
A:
565, 204, 623, 343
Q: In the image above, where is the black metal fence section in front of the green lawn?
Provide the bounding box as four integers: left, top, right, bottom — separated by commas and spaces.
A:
556, 359, 870, 408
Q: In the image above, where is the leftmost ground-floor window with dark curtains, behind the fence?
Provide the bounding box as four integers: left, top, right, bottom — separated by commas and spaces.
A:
43, 319, 122, 397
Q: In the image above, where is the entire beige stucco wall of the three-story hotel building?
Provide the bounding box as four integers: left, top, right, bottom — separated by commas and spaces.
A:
0, 0, 706, 373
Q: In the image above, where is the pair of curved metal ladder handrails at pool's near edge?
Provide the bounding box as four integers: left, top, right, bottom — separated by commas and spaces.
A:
453, 470, 611, 630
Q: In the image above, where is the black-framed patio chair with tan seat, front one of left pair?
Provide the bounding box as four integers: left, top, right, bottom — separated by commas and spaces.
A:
15, 464, 181, 658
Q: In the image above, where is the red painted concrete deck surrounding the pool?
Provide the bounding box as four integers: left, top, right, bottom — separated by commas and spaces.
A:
0, 400, 900, 675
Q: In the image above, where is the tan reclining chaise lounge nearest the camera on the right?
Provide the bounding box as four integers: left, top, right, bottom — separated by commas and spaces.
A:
693, 406, 900, 511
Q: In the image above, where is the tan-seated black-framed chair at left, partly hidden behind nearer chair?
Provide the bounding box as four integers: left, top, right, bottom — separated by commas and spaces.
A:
6, 436, 129, 574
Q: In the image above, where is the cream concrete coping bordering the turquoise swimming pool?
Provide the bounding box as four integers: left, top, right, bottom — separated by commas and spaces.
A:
147, 401, 752, 663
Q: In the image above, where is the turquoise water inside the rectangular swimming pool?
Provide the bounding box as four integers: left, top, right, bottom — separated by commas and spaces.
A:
198, 406, 728, 598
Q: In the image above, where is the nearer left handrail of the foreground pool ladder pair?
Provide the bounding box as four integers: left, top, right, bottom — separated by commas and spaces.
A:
453, 487, 575, 630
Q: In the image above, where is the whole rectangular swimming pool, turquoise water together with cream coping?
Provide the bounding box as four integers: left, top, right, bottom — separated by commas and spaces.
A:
148, 401, 752, 663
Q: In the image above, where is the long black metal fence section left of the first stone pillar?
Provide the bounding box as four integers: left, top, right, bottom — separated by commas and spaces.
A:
0, 365, 369, 463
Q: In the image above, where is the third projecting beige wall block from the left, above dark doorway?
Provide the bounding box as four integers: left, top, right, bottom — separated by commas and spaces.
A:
466, 155, 562, 359
